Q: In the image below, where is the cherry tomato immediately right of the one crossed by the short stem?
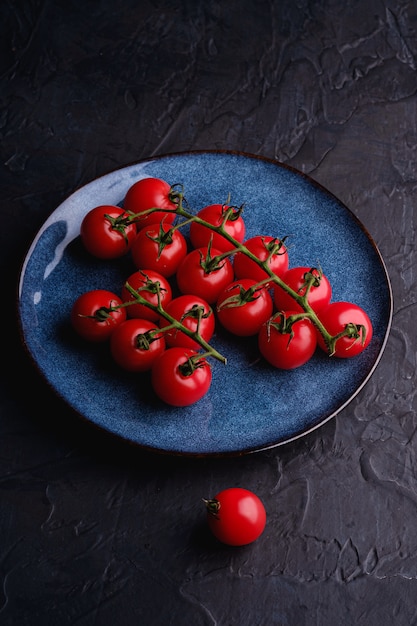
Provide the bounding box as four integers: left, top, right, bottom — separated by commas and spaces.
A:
216, 278, 273, 337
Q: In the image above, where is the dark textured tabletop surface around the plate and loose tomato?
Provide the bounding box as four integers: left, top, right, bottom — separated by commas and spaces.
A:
0, 0, 417, 626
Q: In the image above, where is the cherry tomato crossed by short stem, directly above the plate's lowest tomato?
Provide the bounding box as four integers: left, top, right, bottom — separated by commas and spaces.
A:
159, 294, 215, 350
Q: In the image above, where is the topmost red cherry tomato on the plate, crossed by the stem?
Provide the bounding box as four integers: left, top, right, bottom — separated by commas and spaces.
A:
123, 177, 177, 230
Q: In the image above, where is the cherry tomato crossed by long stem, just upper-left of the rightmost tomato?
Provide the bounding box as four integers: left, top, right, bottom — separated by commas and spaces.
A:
274, 267, 332, 313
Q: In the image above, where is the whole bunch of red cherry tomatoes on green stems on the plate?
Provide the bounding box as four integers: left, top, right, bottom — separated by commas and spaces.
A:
71, 178, 372, 406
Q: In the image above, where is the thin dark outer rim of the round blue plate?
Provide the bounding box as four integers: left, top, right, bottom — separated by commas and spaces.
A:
16, 149, 394, 458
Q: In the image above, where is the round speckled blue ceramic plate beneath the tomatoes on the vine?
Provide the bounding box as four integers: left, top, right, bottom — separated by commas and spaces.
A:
19, 152, 392, 455
